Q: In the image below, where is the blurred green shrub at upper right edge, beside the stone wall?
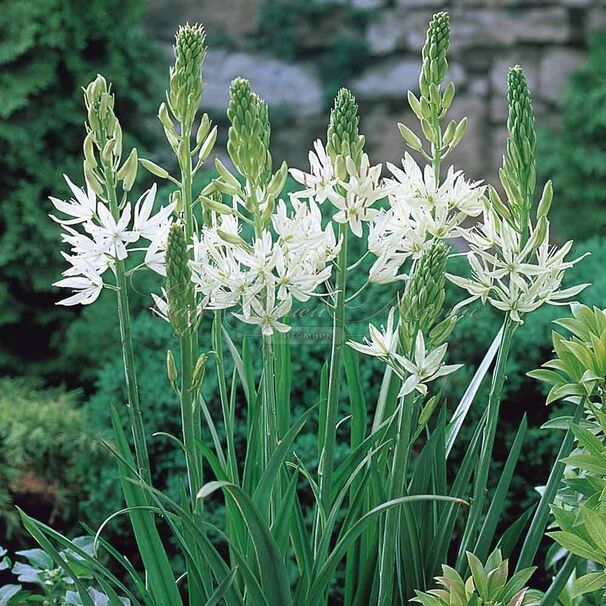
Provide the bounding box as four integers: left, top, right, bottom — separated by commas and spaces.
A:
538, 32, 606, 240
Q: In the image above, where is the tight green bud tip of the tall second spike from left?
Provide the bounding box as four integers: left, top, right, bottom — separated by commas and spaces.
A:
168, 24, 206, 128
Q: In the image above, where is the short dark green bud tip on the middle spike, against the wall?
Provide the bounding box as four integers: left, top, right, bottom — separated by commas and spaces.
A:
326, 88, 364, 164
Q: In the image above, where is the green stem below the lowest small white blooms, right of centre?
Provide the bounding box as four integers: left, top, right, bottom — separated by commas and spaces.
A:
378, 397, 414, 606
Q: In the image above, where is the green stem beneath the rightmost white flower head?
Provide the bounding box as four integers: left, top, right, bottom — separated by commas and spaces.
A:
457, 315, 516, 570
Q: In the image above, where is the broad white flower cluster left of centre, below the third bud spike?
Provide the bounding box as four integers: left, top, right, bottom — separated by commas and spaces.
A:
190, 197, 339, 334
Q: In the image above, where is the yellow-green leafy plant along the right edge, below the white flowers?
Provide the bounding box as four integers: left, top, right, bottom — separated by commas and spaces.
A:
530, 305, 606, 604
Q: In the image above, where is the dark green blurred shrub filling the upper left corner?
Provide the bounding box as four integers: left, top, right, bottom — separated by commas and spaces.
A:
0, 0, 164, 374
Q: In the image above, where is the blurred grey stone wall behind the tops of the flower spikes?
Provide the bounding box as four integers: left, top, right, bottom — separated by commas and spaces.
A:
148, 0, 606, 178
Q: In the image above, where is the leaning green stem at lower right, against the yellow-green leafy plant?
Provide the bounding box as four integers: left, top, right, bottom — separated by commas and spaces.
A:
516, 398, 585, 572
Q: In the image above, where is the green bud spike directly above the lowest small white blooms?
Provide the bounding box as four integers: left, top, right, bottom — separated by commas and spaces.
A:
399, 240, 449, 355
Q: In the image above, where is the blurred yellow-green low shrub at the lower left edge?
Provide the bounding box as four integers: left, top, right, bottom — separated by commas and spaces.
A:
0, 378, 108, 538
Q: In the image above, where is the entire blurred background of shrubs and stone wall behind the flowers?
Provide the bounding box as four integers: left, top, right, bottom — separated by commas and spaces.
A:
0, 0, 606, 588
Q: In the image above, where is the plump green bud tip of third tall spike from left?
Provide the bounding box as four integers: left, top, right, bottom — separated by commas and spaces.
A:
227, 78, 271, 186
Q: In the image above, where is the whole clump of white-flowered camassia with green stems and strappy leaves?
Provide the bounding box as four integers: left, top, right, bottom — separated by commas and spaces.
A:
8, 12, 600, 606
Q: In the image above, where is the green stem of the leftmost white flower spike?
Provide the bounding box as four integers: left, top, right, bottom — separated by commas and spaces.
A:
103, 162, 151, 484
